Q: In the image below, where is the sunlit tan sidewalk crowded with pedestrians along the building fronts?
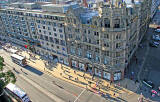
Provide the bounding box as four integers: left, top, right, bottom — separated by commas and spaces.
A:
21, 51, 140, 98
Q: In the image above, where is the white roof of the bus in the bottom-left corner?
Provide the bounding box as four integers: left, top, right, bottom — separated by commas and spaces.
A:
6, 83, 26, 98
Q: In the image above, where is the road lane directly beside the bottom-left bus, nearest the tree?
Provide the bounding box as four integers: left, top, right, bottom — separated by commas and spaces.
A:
16, 76, 55, 102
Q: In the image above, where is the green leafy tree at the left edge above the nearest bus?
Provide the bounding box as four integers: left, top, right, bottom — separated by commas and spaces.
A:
0, 56, 16, 94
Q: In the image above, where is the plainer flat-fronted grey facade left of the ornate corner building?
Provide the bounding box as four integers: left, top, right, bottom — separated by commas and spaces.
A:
0, 3, 68, 65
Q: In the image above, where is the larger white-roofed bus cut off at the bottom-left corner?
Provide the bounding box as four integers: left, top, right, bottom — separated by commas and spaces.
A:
4, 83, 31, 102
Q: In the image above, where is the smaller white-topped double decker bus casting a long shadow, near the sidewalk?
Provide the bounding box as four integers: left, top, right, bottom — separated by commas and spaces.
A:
11, 54, 27, 66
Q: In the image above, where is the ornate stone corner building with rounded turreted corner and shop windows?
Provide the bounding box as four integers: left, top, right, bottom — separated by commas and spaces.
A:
65, 0, 151, 81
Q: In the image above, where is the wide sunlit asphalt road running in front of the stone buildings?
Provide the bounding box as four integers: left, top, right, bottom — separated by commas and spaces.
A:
0, 49, 107, 102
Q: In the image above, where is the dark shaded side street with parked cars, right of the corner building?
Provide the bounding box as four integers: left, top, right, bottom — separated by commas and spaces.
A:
126, 7, 160, 102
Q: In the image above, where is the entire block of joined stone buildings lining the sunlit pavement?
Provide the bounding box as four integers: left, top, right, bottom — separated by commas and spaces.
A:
0, 0, 152, 81
